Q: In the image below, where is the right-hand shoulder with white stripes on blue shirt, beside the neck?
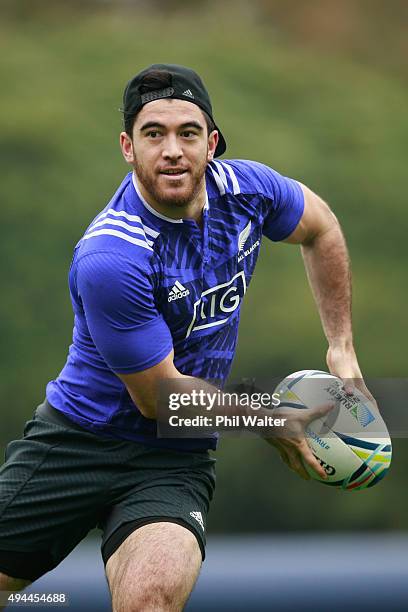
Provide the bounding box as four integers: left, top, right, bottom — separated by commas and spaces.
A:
209, 159, 292, 199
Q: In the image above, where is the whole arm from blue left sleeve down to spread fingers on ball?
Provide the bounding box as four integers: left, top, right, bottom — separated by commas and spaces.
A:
76, 252, 327, 477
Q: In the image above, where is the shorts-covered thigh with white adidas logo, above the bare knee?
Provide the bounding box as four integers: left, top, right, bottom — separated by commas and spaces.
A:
100, 448, 215, 565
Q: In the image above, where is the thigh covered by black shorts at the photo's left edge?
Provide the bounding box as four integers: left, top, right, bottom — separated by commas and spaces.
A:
0, 408, 108, 581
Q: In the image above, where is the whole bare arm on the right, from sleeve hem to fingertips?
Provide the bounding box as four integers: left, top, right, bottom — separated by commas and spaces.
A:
285, 183, 373, 399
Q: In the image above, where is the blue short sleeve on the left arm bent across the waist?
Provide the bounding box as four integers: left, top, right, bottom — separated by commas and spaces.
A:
76, 252, 173, 374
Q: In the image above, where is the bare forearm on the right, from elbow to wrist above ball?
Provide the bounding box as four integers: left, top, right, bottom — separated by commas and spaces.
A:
302, 222, 353, 350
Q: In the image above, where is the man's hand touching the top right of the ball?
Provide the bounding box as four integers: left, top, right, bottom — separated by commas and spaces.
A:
326, 346, 378, 410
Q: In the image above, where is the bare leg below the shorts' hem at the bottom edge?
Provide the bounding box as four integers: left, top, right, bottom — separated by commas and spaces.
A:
106, 522, 201, 612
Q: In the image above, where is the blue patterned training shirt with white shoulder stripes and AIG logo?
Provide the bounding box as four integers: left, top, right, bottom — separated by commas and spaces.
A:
47, 160, 304, 450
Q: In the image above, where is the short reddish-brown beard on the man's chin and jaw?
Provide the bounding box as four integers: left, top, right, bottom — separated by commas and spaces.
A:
135, 156, 208, 208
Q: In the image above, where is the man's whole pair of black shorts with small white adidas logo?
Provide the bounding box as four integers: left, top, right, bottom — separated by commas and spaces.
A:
0, 403, 215, 581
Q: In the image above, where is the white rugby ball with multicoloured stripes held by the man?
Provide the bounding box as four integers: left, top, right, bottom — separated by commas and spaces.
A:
275, 370, 392, 491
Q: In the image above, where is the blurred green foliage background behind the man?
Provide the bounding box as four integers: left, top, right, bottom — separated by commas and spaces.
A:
0, 0, 408, 532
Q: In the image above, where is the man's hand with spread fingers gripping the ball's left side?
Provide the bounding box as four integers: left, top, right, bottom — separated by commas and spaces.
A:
265, 403, 334, 480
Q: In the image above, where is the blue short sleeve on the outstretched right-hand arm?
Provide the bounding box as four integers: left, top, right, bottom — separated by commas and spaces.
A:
245, 162, 304, 241
